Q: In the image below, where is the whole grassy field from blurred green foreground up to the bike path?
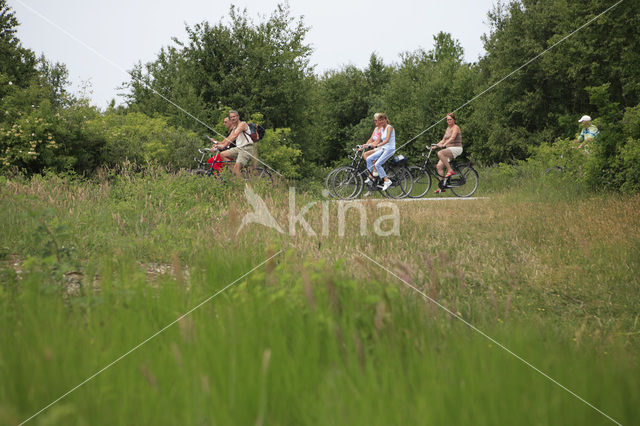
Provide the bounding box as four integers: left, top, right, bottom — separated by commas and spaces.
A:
0, 169, 640, 425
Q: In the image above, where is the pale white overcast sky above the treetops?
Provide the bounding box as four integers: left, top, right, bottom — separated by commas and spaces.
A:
8, 0, 495, 108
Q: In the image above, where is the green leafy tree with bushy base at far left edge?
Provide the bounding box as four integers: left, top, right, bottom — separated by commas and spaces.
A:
0, 0, 104, 174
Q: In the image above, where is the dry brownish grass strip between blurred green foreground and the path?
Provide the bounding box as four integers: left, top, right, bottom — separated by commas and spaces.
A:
1, 175, 640, 345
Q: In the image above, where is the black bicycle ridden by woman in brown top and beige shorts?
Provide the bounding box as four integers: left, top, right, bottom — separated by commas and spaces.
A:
409, 144, 479, 198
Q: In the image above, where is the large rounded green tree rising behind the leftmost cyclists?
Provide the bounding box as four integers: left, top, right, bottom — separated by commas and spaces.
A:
128, 4, 311, 129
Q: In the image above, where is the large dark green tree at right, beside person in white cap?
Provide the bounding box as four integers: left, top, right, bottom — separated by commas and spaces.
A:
469, 0, 640, 163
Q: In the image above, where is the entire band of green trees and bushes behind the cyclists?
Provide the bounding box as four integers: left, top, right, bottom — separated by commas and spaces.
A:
0, 0, 640, 191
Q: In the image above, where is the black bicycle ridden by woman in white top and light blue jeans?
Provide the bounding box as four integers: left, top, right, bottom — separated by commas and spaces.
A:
325, 145, 413, 200
